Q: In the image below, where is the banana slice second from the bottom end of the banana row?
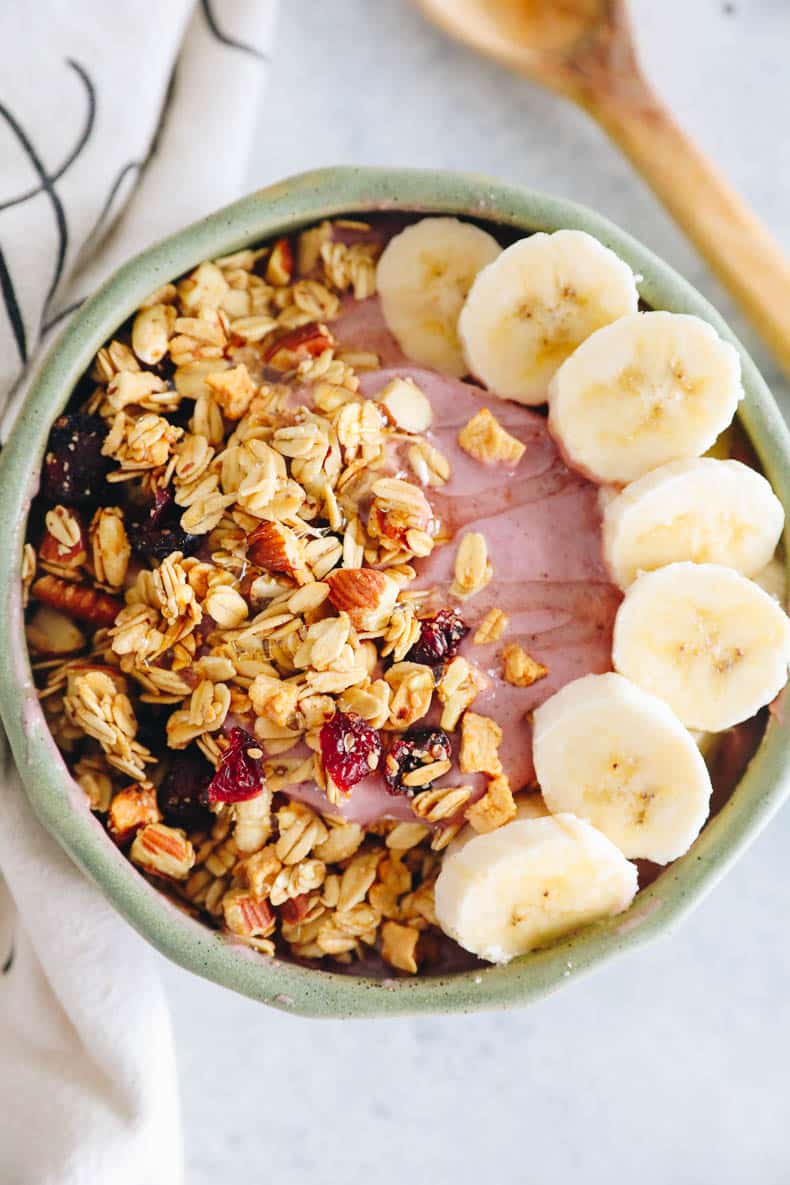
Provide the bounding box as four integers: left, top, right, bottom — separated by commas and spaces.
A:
533, 674, 711, 864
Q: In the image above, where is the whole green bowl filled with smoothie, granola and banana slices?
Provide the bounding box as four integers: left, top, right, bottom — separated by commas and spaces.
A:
0, 169, 790, 1016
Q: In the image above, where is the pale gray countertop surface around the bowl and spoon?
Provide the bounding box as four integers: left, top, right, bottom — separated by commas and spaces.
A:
163, 0, 790, 1185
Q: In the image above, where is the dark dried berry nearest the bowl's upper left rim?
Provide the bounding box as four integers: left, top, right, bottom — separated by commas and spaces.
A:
43, 411, 113, 506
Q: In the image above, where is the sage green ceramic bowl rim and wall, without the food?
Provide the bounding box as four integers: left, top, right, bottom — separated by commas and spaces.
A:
0, 168, 790, 1017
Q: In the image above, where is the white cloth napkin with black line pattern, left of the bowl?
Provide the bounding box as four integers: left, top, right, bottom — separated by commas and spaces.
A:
0, 0, 276, 1185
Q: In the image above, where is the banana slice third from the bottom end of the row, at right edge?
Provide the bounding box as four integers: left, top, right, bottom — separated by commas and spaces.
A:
612, 563, 790, 732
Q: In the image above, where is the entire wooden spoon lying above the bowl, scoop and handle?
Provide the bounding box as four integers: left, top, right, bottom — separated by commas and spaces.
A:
417, 0, 790, 376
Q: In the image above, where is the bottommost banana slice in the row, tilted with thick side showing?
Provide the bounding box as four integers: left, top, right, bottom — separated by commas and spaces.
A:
436, 814, 637, 963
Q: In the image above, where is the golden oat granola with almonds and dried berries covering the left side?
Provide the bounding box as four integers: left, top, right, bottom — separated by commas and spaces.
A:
23, 220, 546, 973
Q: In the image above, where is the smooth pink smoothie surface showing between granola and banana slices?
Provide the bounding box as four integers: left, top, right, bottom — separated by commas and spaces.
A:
280, 297, 621, 824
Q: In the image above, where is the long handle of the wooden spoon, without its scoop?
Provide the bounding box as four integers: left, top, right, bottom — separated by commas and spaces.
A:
584, 79, 790, 377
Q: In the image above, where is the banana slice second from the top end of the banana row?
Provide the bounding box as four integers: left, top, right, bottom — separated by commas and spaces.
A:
458, 230, 638, 404
